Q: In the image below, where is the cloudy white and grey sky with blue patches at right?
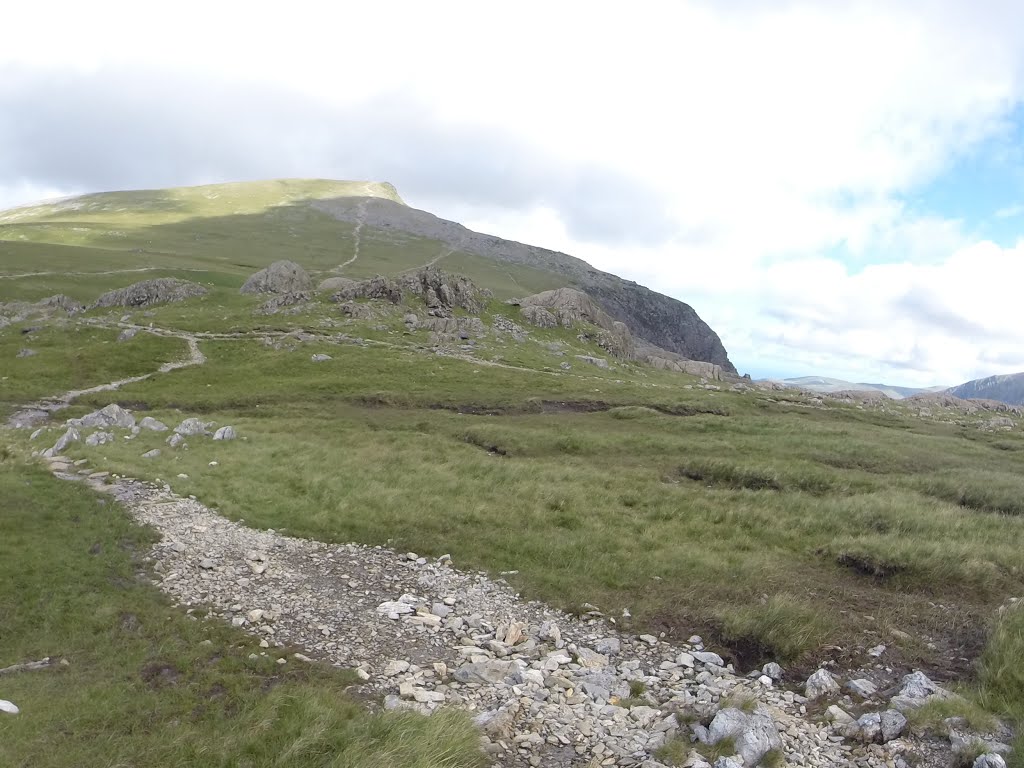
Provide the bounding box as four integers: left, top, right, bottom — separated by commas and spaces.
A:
0, 0, 1024, 386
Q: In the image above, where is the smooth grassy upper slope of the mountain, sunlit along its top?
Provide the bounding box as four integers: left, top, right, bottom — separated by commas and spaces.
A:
0, 180, 567, 301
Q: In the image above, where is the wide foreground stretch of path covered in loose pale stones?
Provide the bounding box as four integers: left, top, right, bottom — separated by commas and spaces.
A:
32, 450, 937, 768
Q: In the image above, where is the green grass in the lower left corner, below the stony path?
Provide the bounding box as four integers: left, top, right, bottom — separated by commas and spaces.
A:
0, 457, 485, 768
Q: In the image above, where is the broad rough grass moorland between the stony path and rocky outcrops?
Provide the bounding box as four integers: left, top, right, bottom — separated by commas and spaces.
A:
48, 342, 1024, 662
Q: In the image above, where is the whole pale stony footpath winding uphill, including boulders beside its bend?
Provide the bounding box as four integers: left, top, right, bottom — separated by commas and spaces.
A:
2, 337, 1007, 768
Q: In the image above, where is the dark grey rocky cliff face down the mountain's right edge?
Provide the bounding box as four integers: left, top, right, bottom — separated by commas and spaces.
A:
312, 198, 736, 374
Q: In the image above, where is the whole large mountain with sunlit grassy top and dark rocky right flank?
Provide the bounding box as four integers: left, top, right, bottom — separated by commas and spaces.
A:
0, 179, 736, 374
